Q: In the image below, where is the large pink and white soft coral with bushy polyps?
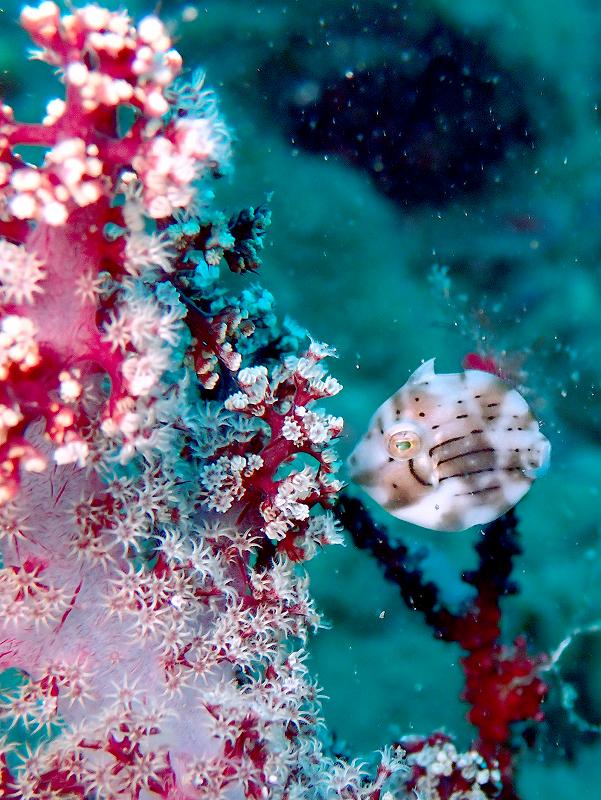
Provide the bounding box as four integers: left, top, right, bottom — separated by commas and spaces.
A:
0, 2, 544, 800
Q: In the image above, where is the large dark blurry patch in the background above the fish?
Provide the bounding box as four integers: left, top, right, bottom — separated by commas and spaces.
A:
263, 9, 534, 207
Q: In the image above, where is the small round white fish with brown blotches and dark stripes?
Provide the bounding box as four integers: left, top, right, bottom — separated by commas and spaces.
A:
347, 358, 551, 531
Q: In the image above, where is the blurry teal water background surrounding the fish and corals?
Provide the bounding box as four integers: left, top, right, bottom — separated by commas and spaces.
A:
0, 0, 601, 800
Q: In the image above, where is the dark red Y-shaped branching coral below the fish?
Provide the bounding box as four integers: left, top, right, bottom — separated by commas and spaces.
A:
335, 495, 548, 800
